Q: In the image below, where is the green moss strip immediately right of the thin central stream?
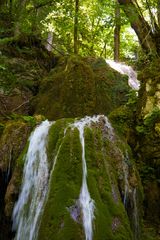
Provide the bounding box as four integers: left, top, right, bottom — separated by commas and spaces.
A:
85, 126, 132, 240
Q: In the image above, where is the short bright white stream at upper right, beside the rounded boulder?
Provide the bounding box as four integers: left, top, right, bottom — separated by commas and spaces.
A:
106, 60, 140, 91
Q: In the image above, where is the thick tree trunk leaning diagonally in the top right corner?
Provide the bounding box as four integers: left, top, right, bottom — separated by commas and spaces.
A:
118, 0, 158, 55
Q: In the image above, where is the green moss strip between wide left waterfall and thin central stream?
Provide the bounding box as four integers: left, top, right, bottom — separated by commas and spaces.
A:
38, 125, 84, 240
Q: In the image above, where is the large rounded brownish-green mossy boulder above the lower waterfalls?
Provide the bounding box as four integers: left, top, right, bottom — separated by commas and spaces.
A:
33, 56, 129, 119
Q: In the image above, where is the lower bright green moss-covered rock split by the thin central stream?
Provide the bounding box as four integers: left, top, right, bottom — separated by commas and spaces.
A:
38, 117, 142, 240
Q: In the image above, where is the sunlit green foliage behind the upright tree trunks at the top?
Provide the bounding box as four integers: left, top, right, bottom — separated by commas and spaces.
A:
0, 0, 137, 58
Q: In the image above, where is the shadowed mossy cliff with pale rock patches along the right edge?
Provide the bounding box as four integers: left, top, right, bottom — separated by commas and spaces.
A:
135, 59, 160, 231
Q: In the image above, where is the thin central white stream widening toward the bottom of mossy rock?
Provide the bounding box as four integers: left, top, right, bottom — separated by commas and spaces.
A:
71, 115, 113, 240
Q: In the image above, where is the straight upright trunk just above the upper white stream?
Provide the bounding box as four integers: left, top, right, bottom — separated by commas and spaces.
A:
114, 0, 121, 62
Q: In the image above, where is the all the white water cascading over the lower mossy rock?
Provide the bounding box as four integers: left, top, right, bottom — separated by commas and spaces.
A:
10, 115, 139, 240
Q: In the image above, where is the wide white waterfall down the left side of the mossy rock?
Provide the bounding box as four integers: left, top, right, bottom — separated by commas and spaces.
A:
13, 120, 52, 240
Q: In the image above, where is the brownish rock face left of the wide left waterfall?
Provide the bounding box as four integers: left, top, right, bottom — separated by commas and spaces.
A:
0, 120, 31, 239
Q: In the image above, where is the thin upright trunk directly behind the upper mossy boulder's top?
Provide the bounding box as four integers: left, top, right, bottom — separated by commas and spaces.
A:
74, 0, 79, 54
